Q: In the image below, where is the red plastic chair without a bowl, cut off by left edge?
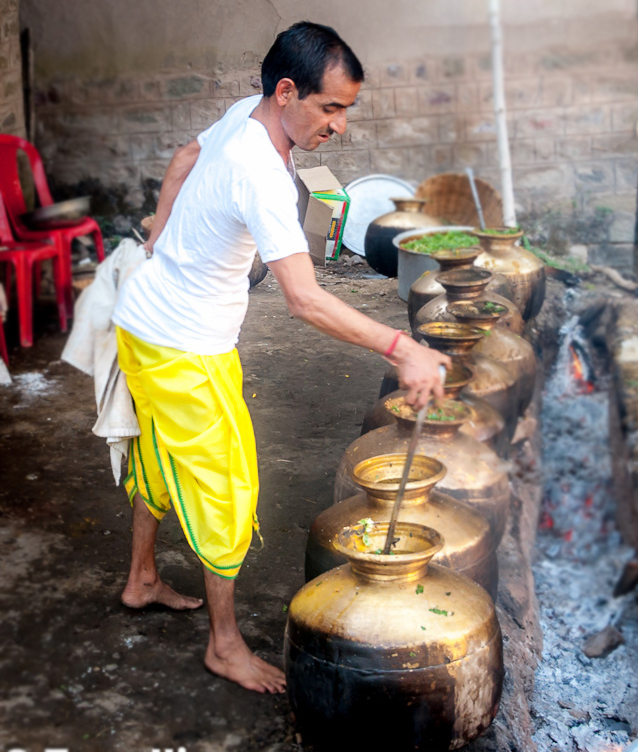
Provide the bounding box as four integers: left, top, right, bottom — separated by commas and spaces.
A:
0, 195, 67, 348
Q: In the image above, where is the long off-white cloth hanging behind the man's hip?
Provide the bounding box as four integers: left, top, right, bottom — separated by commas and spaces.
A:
62, 239, 146, 485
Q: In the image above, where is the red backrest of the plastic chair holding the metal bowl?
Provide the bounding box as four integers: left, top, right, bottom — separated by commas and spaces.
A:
0, 133, 53, 223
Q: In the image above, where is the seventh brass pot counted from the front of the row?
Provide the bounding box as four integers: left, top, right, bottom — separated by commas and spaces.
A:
412, 267, 524, 334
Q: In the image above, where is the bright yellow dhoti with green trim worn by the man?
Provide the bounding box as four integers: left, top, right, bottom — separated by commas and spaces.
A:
117, 327, 259, 578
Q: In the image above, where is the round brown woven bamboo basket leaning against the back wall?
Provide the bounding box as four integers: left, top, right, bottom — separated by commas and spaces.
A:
414, 172, 503, 227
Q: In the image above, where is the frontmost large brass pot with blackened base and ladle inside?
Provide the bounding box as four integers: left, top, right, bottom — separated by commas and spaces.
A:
285, 522, 503, 752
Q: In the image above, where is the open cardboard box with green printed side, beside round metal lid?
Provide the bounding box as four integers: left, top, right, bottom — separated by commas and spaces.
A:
296, 166, 350, 266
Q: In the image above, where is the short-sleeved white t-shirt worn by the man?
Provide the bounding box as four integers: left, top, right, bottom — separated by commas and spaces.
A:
113, 96, 308, 355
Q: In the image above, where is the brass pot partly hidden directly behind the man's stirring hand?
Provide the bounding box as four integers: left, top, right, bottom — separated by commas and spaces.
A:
368, 362, 510, 458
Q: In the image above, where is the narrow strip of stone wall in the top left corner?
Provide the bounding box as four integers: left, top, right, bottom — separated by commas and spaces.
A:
0, 0, 26, 138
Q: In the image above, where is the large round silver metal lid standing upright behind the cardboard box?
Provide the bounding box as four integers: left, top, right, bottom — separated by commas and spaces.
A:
343, 174, 414, 256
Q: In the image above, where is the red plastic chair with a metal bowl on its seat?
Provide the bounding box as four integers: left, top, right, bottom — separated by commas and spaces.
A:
0, 133, 104, 317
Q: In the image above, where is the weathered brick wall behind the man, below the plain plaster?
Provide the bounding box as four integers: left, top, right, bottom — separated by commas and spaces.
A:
30, 7, 638, 268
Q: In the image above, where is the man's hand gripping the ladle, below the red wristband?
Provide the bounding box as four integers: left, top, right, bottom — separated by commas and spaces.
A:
392, 334, 452, 410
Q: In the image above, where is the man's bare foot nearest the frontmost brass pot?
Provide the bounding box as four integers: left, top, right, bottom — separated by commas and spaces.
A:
204, 637, 286, 694
